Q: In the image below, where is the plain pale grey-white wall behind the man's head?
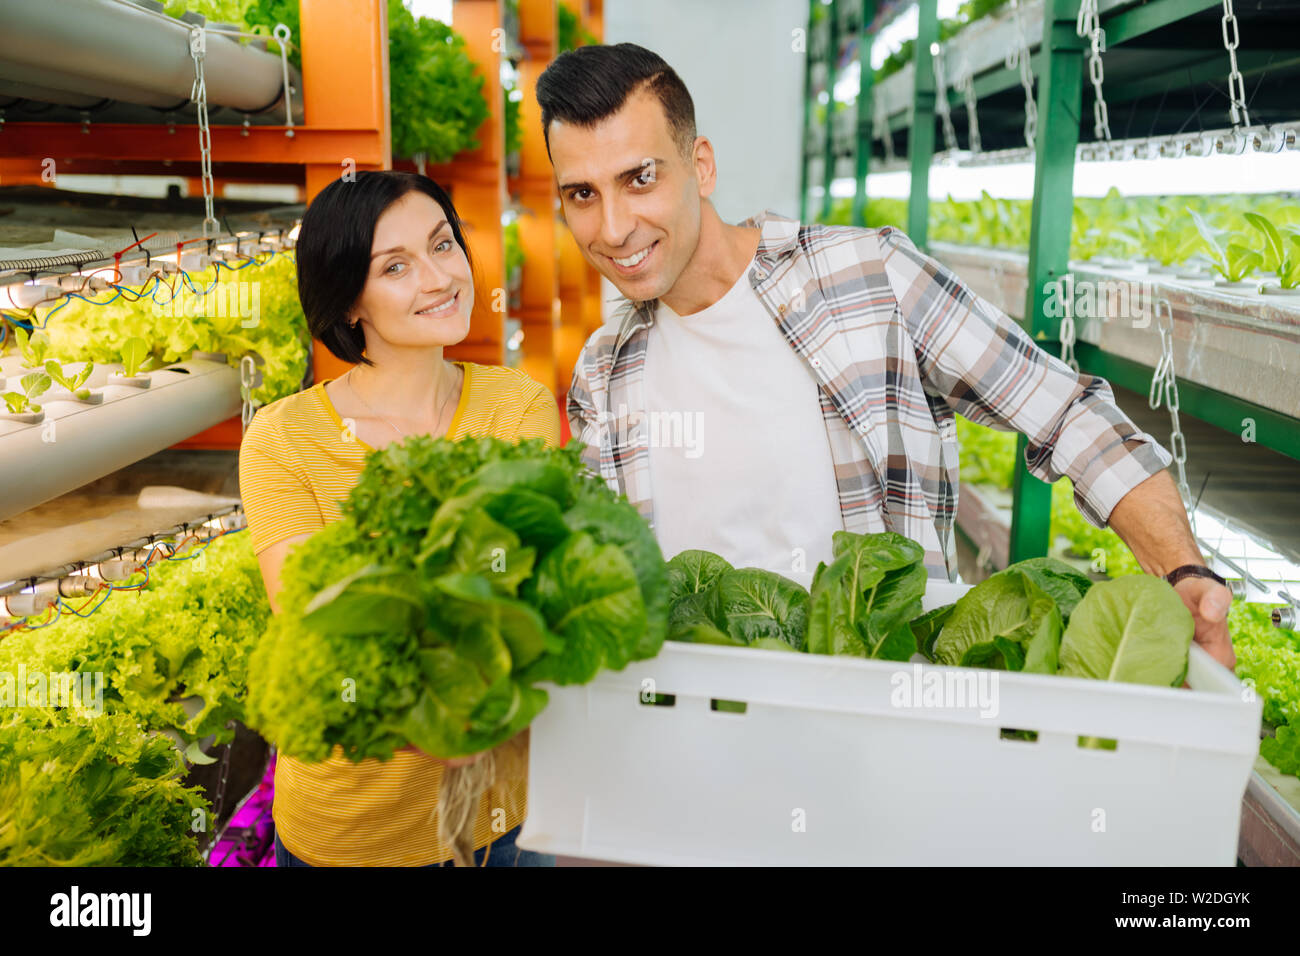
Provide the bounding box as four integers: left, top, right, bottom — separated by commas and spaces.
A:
605, 0, 809, 222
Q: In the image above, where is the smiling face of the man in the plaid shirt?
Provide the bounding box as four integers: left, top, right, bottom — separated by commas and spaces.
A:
550, 90, 712, 300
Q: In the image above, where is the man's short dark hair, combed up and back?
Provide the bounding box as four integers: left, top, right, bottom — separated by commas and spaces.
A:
537, 43, 696, 156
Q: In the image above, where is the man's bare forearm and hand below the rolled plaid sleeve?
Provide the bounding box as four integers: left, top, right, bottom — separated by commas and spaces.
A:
1110, 455, 1236, 669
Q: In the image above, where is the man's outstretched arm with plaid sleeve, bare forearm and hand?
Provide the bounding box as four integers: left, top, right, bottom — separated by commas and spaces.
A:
880, 230, 1234, 667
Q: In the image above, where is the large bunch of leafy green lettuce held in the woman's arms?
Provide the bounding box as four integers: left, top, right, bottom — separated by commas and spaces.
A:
248, 436, 668, 761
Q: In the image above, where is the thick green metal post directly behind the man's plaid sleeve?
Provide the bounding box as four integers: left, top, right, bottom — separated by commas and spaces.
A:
1010, 0, 1084, 562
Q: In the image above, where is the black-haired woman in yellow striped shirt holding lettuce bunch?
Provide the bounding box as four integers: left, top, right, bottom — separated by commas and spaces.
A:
239, 172, 560, 866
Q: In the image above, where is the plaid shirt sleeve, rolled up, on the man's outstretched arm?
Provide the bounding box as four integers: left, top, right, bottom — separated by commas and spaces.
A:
880, 229, 1173, 528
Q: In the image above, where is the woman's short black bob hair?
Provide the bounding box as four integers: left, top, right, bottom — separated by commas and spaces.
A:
295, 169, 473, 365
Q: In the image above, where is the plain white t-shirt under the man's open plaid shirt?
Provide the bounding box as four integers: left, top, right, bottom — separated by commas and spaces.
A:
644, 267, 844, 575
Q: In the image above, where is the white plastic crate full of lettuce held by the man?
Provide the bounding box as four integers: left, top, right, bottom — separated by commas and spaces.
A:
519, 581, 1262, 866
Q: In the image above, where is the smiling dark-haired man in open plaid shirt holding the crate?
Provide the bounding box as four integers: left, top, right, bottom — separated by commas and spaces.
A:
537, 43, 1235, 666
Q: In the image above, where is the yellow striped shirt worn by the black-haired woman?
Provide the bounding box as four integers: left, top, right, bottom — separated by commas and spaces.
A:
239, 363, 560, 866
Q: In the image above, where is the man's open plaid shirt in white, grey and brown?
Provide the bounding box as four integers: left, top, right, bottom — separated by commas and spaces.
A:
568, 212, 1173, 580
